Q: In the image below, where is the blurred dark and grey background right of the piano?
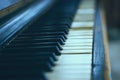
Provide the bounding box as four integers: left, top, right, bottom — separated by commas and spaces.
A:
103, 0, 120, 80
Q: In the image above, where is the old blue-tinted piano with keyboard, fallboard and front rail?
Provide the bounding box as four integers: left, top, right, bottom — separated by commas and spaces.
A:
0, 0, 111, 80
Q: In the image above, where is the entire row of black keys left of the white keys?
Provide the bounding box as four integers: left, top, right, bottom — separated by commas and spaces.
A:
0, 0, 79, 80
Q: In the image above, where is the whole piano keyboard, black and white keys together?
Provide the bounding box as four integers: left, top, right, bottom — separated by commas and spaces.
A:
0, 0, 95, 80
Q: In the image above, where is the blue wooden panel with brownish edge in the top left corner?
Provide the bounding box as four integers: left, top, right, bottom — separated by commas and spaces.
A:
0, 0, 33, 18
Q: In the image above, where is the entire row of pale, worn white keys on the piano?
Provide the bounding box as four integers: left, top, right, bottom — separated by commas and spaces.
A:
46, 0, 95, 80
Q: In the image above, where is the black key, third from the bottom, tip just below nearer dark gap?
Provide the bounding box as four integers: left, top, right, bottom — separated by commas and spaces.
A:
0, 55, 55, 66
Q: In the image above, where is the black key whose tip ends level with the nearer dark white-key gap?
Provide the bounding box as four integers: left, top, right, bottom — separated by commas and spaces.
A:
1, 46, 61, 55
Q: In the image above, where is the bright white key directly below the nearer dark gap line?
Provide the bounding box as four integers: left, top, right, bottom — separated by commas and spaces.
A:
58, 54, 92, 64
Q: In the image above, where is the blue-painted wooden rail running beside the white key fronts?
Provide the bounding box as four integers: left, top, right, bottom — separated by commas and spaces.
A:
92, 2, 104, 80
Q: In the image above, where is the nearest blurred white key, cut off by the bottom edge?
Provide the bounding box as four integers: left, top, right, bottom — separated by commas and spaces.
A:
46, 71, 91, 80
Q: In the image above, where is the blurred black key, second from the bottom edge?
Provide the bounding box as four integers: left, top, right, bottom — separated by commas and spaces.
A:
0, 58, 53, 71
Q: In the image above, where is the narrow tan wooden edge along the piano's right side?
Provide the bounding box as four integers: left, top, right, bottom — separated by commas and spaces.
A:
100, 3, 112, 80
